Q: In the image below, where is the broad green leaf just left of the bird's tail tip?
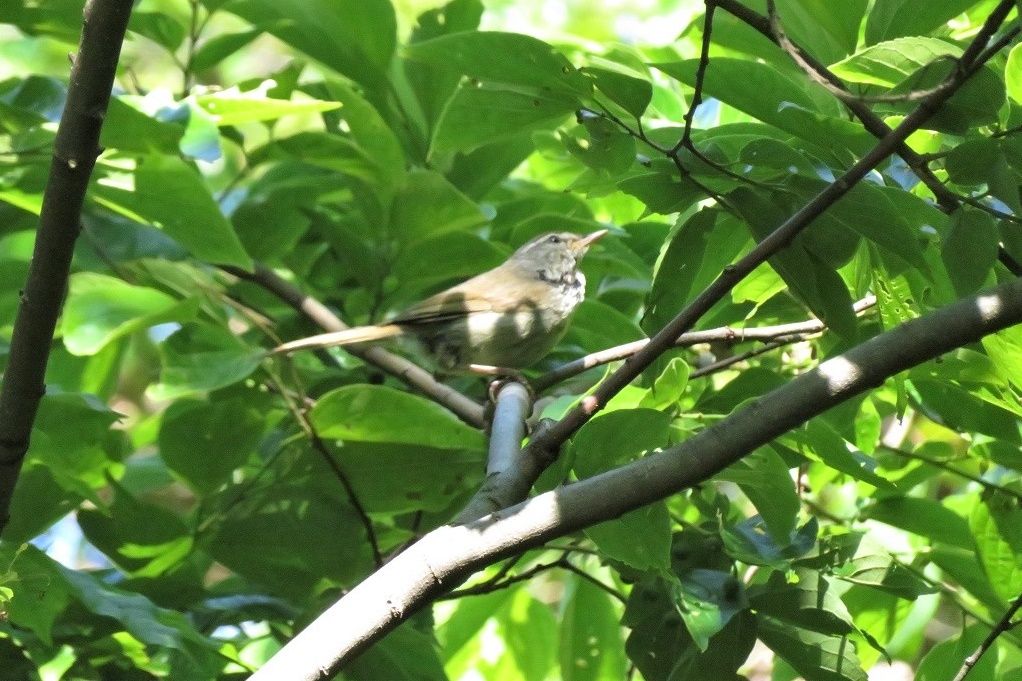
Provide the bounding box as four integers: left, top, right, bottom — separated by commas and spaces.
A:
148, 324, 264, 400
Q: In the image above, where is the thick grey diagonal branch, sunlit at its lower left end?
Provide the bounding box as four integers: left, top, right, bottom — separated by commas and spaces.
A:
251, 279, 1022, 681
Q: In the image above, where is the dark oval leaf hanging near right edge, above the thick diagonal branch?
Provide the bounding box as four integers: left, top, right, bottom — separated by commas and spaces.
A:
941, 207, 1000, 296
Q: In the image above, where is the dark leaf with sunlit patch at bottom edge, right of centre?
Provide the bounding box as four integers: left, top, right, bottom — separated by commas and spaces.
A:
757, 616, 867, 681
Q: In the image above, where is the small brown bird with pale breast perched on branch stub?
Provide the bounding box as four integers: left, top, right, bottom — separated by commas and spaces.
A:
274, 229, 607, 370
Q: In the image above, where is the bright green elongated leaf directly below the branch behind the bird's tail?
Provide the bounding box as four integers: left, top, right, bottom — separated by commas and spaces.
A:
309, 385, 484, 449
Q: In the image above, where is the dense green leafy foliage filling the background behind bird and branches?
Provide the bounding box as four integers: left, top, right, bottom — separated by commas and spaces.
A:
0, 0, 1022, 681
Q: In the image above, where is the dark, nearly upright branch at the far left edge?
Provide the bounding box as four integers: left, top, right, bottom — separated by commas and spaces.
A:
0, 0, 132, 531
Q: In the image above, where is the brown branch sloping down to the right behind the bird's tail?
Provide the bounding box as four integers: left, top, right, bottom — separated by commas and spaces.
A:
221, 263, 485, 428
